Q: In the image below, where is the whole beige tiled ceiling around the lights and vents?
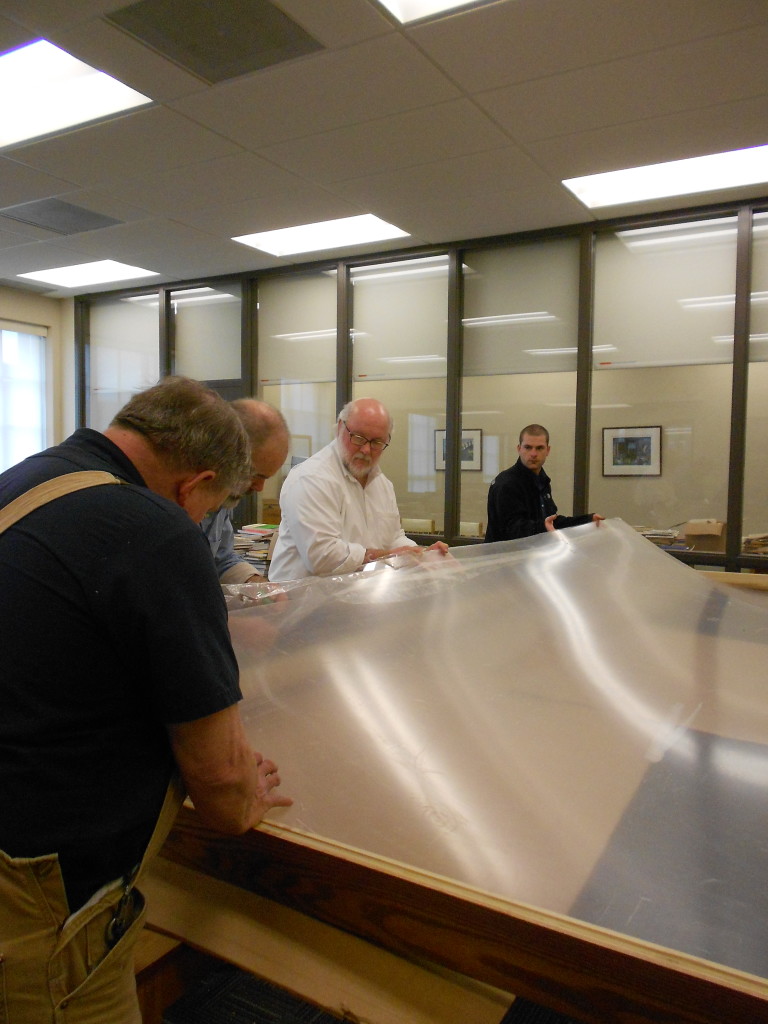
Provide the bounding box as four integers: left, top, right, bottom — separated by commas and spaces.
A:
0, 0, 768, 294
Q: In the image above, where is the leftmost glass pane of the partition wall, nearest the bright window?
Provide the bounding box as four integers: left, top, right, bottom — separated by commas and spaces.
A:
86, 293, 160, 430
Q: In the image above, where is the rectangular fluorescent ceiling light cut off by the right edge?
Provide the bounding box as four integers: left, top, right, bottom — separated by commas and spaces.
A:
563, 145, 768, 210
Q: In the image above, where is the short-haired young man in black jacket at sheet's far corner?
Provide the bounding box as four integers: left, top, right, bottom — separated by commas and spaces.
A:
485, 423, 603, 544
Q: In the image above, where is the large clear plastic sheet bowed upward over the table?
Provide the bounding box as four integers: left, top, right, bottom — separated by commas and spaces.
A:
227, 520, 768, 977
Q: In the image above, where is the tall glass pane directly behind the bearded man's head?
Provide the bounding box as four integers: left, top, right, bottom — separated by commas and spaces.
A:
351, 256, 449, 534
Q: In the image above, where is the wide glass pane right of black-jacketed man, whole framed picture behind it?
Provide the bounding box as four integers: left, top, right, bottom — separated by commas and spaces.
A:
590, 217, 736, 551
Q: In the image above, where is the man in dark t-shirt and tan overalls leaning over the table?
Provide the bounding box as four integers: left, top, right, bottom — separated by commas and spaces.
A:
0, 378, 290, 1024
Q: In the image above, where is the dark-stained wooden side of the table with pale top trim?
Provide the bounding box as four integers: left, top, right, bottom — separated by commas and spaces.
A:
157, 808, 768, 1024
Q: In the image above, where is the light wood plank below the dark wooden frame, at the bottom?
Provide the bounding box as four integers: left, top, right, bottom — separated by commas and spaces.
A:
142, 858, 514, 1024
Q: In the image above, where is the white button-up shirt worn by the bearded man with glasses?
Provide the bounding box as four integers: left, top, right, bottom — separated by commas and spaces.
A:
269, 440, 418, 582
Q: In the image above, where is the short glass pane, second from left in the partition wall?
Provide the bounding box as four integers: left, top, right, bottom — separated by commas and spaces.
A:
171, 281, 243, 381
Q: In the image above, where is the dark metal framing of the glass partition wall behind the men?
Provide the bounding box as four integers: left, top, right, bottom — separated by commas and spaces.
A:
75, 197, 768, 570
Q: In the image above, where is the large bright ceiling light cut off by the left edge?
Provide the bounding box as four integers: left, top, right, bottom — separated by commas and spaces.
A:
0, 39, 152, 146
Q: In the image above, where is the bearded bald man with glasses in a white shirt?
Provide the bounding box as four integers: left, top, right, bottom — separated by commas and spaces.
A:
269, 398, 447, 582
